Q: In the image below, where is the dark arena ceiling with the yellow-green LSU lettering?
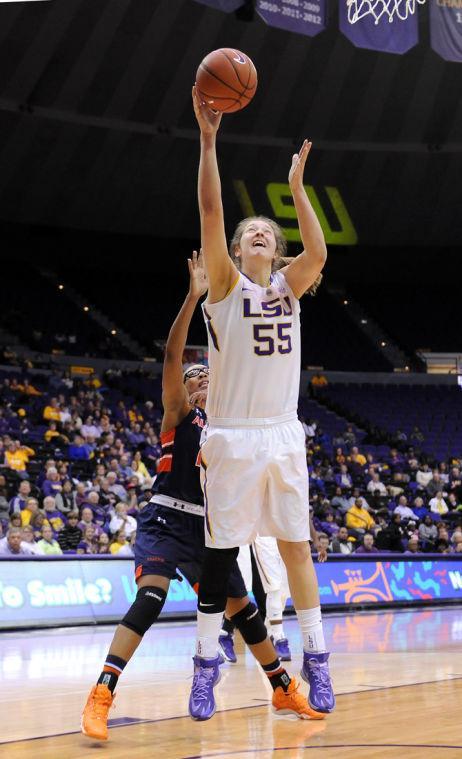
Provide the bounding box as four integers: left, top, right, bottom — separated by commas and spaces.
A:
0, 0, 462, 245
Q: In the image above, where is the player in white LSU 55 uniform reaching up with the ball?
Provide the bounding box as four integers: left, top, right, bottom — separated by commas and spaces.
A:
189, 88, 335, 718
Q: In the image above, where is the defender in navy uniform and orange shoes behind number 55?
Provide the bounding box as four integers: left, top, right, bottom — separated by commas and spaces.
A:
82, 253, 317, 740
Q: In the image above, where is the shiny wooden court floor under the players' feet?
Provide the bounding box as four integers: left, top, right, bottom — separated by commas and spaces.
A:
0, 607, 462, 759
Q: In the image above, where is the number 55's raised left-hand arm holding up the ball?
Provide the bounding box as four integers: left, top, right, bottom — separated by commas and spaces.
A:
193, 87, 238, 303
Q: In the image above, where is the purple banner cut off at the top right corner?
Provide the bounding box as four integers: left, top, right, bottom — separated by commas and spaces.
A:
429, 0, 462, 63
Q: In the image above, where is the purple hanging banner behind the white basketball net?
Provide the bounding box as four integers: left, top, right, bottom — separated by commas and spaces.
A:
338, 0, 419, 55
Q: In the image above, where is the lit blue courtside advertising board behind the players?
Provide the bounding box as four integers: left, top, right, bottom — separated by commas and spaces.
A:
0, 556, 462, 629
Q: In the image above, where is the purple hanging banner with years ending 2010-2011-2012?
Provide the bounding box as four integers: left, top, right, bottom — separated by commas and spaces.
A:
255, 0, 326, 37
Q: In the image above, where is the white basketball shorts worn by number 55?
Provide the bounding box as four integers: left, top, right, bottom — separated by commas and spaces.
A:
201, 418, 310, 548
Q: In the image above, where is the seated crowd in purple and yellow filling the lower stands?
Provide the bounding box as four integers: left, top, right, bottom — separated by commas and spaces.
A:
0, 370, 462, 556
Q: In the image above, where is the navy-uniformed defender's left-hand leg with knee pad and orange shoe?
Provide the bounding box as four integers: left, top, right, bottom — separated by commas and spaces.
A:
82, 575, 170, 740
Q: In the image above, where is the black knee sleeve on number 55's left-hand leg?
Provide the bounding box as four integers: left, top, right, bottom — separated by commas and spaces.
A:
197, 548, 239, 614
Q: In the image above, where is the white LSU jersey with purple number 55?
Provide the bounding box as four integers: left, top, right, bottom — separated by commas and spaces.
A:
202, 272, 300, 426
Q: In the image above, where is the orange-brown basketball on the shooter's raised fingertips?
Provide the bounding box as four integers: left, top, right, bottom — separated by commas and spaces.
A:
196, 47, 257, 113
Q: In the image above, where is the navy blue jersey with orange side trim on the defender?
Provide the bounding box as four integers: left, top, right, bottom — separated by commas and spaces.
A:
152, 407, 207, 505
